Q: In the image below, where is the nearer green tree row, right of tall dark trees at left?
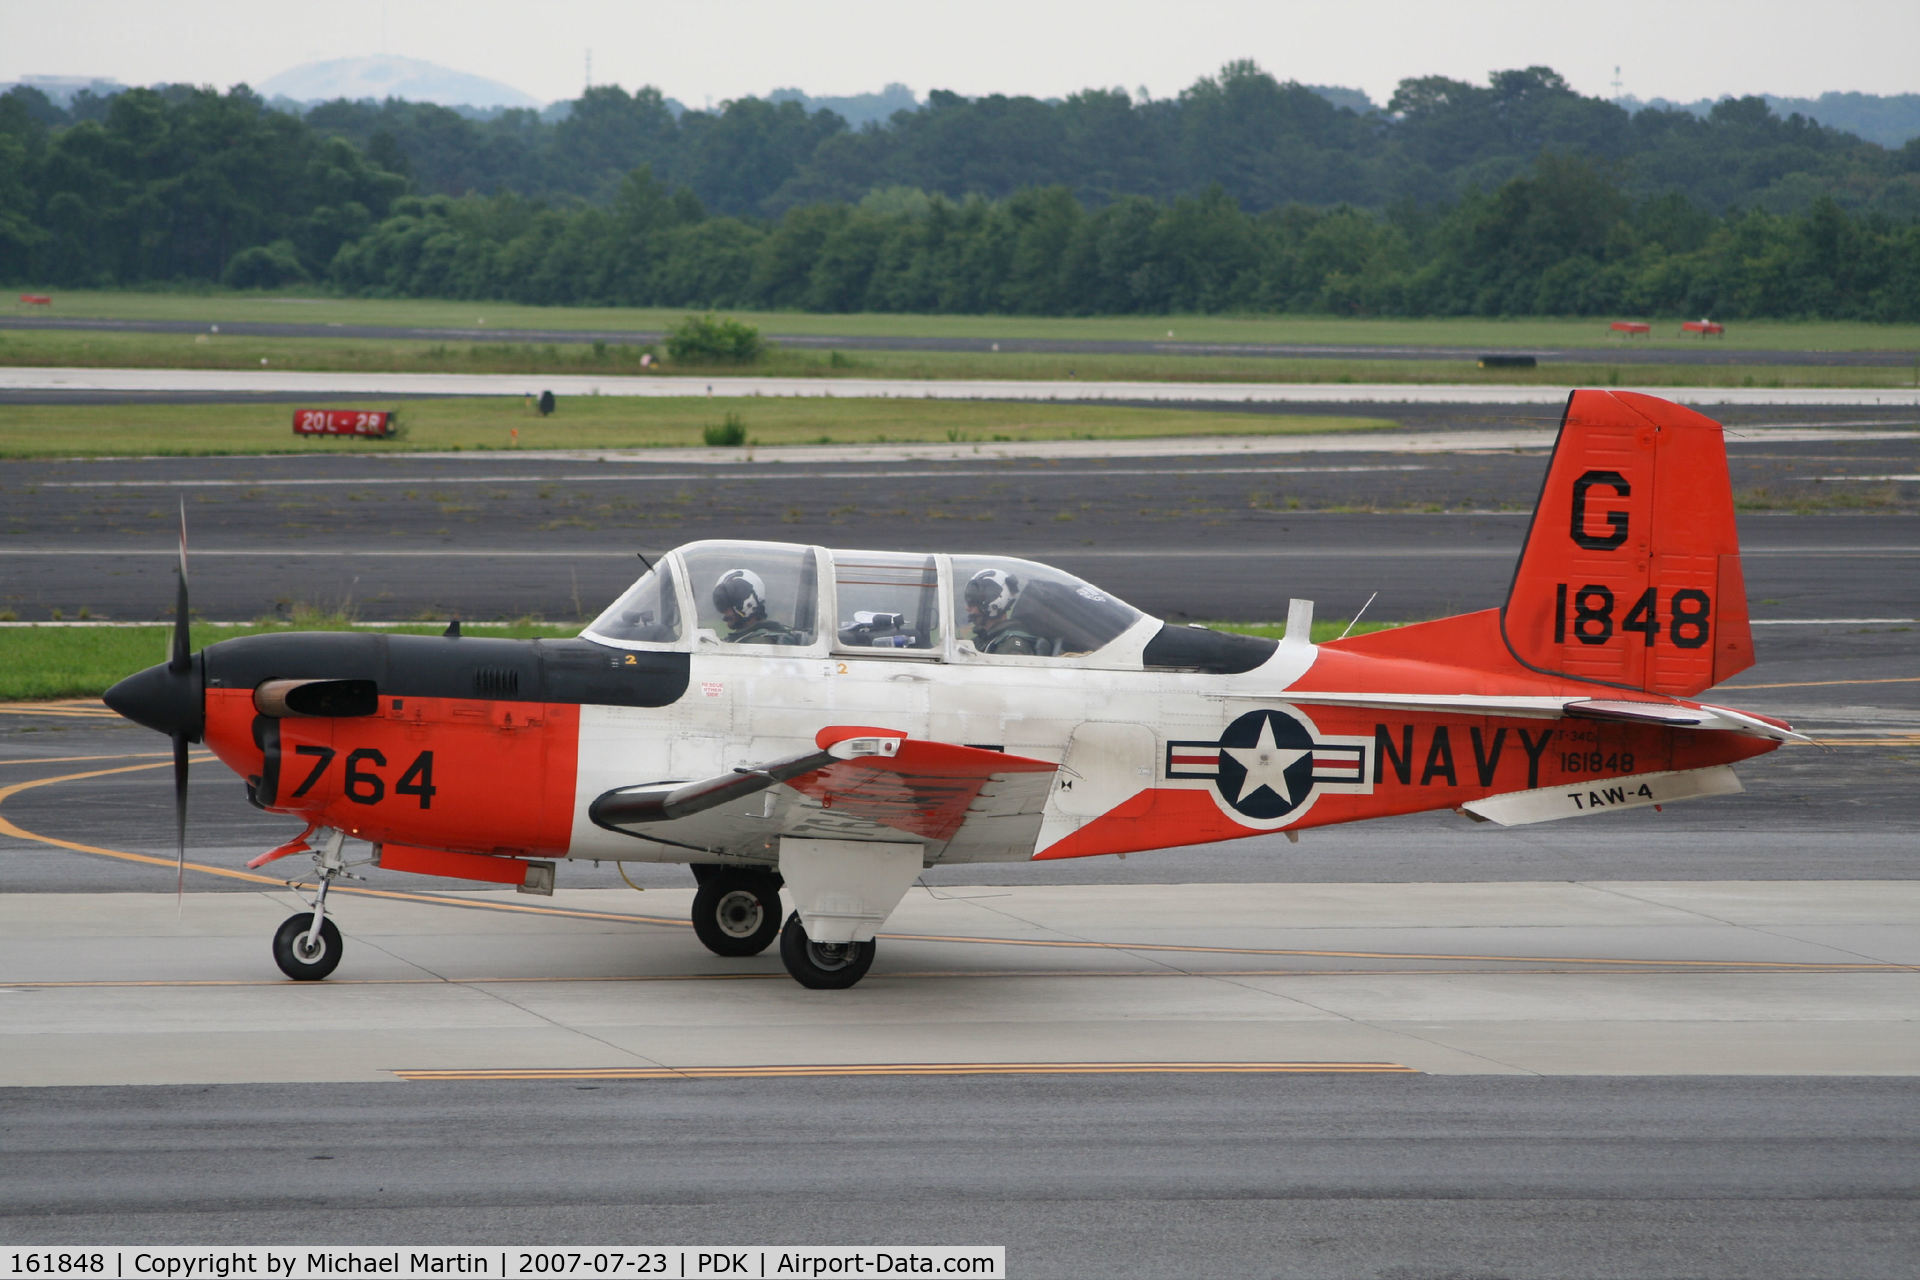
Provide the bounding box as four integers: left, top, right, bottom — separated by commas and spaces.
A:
299, 152, 1920, 320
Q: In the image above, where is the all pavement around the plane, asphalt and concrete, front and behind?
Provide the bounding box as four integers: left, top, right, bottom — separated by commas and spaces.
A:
0, 391, 1920, 1278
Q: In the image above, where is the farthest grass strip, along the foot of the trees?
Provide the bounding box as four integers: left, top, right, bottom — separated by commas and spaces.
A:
11, 284, 1920, 351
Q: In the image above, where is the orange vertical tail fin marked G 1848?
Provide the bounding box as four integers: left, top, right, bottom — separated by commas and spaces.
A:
1500, 391, 1753, 697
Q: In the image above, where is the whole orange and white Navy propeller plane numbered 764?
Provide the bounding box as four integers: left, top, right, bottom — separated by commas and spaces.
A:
106, 391, 1805, 986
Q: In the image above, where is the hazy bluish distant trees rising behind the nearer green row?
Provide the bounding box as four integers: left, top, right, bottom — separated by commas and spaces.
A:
206, 61, 1920, 217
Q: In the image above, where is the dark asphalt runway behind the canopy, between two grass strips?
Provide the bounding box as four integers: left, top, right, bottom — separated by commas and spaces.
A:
0, 405, 1920, 622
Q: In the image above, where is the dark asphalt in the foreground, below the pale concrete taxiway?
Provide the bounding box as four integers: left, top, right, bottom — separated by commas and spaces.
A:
0, 1077, 1920, 1280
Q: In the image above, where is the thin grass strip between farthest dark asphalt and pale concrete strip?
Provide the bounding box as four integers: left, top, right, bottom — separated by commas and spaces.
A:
0, 330, 1920, 388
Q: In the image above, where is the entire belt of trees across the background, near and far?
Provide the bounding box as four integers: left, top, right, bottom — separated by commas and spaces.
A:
0, 63, 1920, 320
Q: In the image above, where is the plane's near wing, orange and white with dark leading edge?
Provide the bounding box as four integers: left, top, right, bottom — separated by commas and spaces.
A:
588, 725, 1058, 860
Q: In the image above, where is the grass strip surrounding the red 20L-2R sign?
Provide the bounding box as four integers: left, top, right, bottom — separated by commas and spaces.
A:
0, 395, 1394, 459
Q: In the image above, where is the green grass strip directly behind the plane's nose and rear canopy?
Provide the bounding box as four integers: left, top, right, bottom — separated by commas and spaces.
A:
0, 616, 1398, 702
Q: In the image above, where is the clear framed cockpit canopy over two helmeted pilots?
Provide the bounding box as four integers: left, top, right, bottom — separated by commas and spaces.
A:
582, 541, 1228, 670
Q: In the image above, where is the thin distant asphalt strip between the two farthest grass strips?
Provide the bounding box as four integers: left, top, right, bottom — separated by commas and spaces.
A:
0, 317, 1916, 368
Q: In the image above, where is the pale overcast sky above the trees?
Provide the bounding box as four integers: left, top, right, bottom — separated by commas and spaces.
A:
0, 0, 1920, 107
